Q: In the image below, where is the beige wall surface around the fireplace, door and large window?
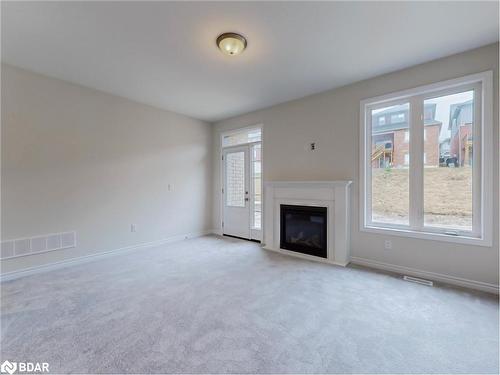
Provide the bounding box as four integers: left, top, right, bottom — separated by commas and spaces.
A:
213, 43, 499, 285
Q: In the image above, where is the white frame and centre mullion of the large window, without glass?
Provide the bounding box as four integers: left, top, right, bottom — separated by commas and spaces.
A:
359, 71, 493, 246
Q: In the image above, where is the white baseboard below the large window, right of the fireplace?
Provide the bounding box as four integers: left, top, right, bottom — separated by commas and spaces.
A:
351, 257, 499, 294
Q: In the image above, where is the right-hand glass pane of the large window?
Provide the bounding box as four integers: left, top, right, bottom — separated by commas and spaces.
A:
424, 90, 474, 231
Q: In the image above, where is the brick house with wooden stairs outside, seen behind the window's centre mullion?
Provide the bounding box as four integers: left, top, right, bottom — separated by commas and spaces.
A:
372, 103, 442, 168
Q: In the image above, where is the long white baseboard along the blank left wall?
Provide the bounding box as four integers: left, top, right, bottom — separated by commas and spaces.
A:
0, 229, 214, 282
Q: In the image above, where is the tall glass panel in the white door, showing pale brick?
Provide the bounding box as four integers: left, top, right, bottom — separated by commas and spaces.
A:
226, 151, 245, 207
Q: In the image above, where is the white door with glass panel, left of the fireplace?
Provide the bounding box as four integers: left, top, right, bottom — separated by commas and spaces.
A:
222, 146, 250, 239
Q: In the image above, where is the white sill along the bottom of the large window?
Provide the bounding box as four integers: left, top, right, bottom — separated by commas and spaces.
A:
361, 225, 492, 247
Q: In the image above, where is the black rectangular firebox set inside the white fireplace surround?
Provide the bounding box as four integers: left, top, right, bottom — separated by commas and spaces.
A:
280, 204, 328, 258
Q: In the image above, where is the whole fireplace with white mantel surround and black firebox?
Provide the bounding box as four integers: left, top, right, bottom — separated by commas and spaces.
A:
263, 181, 351, 267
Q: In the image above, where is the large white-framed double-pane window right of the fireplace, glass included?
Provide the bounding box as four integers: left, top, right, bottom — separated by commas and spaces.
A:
360, 72, 493, 246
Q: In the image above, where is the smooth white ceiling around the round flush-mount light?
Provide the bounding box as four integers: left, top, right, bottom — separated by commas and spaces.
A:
2, 1, 499, 121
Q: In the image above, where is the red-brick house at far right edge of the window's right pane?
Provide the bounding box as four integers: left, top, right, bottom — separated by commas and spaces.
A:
448, 100, 473, 167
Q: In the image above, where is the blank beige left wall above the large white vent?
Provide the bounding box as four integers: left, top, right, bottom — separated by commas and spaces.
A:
1, 65, 212, 272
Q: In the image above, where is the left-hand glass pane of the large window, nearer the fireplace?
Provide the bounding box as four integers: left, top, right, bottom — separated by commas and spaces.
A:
370, 103, 411, 225
